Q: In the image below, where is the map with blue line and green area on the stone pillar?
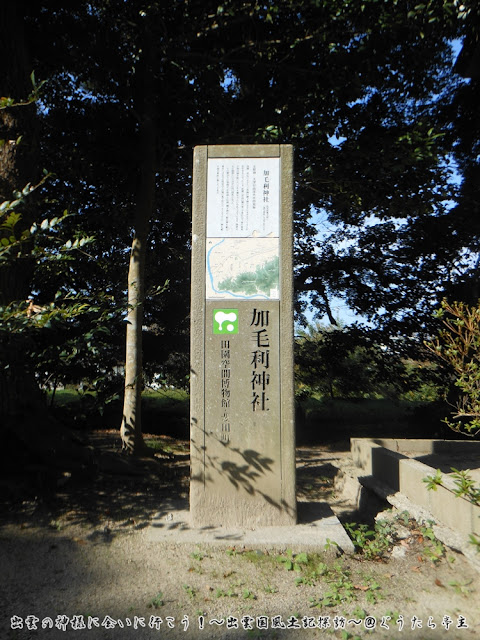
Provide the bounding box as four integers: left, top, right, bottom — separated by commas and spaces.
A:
206, 237, 279, 300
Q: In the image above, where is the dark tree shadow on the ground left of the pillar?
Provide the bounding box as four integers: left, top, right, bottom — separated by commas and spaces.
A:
0, 431, 190, 531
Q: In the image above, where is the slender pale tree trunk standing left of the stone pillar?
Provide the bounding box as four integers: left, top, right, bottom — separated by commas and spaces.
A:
120, 38, 156, 455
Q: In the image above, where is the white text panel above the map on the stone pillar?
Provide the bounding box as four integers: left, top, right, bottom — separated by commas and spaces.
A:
207, 158, 280, 238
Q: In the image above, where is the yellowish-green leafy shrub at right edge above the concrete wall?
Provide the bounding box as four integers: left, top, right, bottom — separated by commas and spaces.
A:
425, 299, 480, 437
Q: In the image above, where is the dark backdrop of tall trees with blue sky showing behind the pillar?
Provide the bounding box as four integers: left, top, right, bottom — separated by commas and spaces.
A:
0, 0, 480, 468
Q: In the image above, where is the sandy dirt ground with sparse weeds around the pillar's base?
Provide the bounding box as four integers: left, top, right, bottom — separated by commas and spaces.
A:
0, 431, 480, 640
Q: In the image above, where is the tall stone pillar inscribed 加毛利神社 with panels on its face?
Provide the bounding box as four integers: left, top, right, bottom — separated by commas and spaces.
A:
190, 145, 296, 528
